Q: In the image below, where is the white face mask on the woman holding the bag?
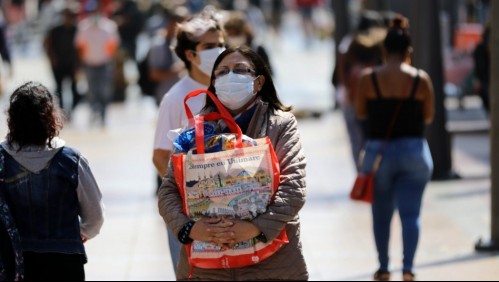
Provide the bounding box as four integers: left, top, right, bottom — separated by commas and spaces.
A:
215, 71, 256, 110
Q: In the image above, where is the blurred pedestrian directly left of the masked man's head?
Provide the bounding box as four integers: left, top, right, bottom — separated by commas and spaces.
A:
147, 8, 187, 106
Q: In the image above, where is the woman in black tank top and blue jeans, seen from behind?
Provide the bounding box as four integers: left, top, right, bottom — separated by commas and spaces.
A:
356, 16, 434, 281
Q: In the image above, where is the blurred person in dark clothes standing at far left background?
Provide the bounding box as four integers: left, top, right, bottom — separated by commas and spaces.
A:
43, 8, 81, 117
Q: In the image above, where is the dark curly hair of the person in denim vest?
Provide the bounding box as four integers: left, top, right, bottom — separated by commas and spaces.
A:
7, 82, 63, 150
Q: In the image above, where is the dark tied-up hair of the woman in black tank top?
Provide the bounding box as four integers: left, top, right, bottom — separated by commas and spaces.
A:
384, 15, 411, 55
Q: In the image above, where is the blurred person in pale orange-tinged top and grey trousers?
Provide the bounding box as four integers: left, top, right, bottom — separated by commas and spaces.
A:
75, 0, 120, 127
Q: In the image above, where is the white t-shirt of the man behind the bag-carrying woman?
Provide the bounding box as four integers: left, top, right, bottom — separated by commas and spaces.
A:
154, 75, 207, 151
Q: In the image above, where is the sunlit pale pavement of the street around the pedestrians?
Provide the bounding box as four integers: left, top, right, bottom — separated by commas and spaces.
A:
0, 10, 499, 281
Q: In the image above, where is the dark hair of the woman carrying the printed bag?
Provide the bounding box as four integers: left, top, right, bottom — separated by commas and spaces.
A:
205, 46, 292, 112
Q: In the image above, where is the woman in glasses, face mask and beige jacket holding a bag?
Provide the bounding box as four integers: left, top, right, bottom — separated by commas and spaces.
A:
158, 47, 308, 281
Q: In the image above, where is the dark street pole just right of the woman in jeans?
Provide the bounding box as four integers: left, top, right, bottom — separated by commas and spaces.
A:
410, 0, 456, 180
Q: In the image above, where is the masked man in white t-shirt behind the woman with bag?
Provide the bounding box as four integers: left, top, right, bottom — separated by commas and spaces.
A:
153, 13, 224, 270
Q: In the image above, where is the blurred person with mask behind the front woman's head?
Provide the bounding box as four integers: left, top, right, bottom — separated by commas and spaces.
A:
224, 11, 273, 74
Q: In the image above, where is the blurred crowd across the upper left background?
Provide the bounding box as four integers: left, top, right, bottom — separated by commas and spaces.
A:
0, 0, 334, 126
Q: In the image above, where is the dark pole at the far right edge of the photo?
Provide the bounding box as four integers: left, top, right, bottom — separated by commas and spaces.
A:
475, 1, 499, 251
